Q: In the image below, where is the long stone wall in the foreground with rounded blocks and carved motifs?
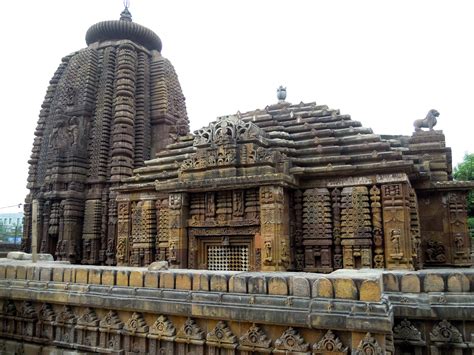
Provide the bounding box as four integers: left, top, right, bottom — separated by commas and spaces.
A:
0, 259, 474, 354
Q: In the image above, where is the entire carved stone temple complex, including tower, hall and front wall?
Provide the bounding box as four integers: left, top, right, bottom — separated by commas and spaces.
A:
7, 8, 474, 355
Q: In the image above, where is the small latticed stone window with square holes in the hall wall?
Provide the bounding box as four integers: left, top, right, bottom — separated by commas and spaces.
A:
207, 245, 249, 271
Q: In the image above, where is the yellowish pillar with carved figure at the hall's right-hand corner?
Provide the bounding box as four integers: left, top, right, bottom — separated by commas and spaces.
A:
382, 183, 413, 269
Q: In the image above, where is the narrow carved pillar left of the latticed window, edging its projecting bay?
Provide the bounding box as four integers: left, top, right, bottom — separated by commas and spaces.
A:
168, 193, 189, 268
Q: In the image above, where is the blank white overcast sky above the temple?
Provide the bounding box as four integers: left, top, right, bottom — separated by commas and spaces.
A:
0, 0, 474, 213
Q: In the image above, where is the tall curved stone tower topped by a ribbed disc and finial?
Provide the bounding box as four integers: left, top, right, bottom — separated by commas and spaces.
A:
24, 9, 188, 264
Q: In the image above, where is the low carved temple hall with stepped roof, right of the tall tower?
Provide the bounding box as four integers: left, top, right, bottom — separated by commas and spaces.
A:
112, 94, 471, 272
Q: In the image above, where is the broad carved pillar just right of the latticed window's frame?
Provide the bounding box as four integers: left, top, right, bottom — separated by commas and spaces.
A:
260, 186, 290, 271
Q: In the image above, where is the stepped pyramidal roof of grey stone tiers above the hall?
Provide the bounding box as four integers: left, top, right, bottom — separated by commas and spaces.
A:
120, 102, 413, 187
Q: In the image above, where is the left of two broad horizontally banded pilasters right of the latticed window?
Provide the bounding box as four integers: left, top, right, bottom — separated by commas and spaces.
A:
303, 188, 333, 272
